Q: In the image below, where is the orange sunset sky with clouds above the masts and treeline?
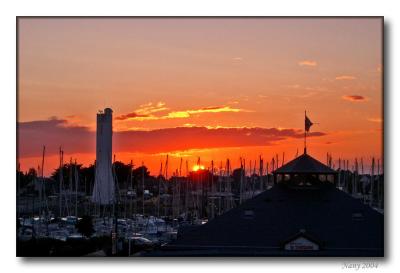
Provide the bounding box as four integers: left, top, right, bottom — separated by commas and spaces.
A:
18, 18, 383, 174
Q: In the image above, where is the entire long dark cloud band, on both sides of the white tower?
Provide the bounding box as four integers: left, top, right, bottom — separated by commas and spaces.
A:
18, 119, 325, 157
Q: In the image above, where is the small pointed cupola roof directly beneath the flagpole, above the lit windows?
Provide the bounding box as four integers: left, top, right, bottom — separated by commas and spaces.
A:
273, 153, 336, 174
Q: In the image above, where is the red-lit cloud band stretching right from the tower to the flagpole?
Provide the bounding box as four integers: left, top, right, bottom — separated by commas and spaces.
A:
115, 127, 324, 153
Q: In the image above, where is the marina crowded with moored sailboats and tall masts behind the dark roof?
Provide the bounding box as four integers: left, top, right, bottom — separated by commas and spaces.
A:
17, 109, 384, 256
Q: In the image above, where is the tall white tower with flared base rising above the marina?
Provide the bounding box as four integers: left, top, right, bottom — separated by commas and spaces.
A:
92, 108, 115, 205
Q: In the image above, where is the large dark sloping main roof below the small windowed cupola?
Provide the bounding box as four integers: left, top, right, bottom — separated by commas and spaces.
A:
146, 183, 384, 256
